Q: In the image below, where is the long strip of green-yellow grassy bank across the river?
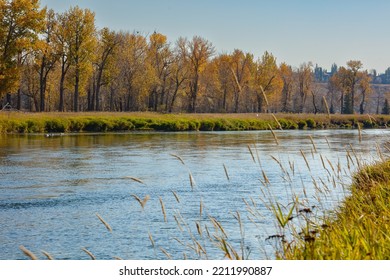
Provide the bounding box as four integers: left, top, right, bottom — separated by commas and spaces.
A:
0, 112, 390, 134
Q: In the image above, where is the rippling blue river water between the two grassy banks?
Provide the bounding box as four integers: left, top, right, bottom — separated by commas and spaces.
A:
0, 130, 390, 259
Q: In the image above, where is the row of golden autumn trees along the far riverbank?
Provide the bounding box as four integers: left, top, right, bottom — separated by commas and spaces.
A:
0, 0, 387, 114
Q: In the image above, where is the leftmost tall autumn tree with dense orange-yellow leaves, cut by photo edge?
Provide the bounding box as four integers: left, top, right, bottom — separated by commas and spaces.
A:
0, 0, 46, 106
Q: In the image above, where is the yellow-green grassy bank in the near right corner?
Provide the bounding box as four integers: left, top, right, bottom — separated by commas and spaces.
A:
281, 161, 390, 260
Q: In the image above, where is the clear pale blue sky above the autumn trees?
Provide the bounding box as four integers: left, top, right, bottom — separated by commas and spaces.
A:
41, 0, 390, 73
